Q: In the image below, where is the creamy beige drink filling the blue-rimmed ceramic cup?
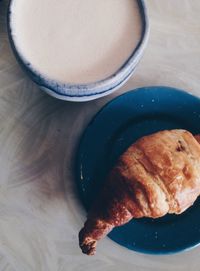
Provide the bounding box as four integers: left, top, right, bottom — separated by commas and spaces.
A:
11, 0, 142, 83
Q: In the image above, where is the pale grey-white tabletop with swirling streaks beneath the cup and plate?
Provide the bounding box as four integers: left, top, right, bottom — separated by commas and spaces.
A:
0, 0, 200, 271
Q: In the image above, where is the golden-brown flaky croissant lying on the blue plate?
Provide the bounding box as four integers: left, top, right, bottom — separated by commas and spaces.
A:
79, 130, 200, 255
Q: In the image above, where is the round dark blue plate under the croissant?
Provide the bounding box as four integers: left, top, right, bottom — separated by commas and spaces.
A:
76, 87, 200, 254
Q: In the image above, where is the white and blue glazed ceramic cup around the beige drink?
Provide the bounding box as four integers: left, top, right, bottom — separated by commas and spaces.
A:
7, 0, 149, 102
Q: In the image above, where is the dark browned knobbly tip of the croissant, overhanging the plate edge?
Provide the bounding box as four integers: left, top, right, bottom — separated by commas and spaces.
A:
79, 229, 97, 256
